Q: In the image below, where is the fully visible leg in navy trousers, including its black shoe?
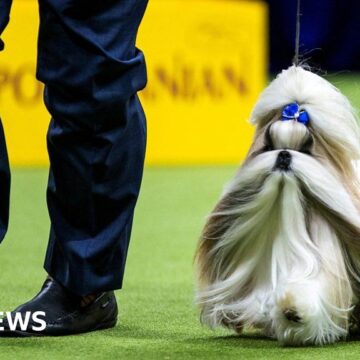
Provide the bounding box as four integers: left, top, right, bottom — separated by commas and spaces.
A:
0, 0, 147, 335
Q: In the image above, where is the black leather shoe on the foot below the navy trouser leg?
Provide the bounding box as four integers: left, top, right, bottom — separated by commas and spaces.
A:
0, 279, 118, 337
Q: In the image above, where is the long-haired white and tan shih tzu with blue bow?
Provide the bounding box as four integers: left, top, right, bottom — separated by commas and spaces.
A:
196, 66, 360, 345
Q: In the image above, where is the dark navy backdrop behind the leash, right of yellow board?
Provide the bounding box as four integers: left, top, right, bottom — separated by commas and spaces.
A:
267, 0, 360, 72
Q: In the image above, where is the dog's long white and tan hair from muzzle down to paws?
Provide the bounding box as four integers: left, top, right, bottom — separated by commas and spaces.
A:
197, 150, 360, 345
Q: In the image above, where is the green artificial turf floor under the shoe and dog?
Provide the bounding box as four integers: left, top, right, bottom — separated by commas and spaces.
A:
0, 75, 360, 360
